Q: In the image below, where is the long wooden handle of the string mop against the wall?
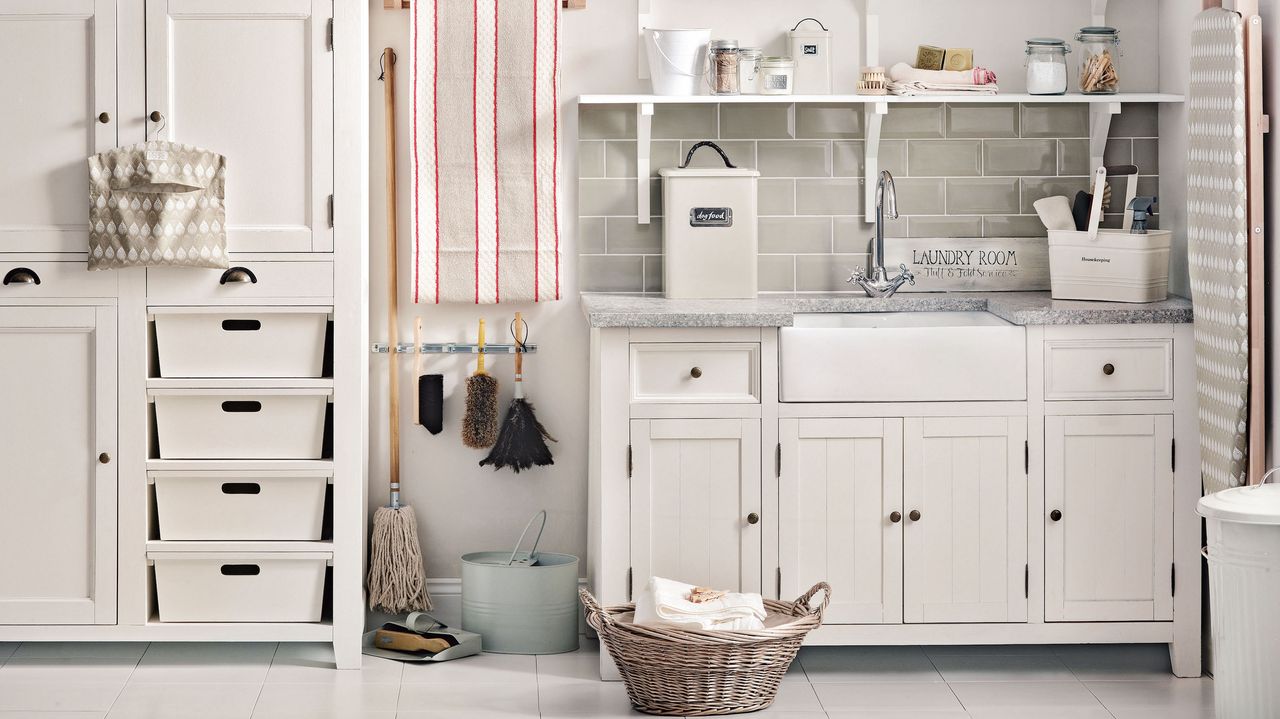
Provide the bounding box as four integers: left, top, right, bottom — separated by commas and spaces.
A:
383, 47, 399, 486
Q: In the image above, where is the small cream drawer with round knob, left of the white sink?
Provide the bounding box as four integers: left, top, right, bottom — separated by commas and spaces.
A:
631, 343, 760, 404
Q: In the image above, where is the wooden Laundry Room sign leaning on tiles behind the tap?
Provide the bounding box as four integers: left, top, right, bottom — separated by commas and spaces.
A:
884, 237, 1050, 292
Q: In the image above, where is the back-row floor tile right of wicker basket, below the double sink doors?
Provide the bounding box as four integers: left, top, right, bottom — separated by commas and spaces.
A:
799, 646, 942, 684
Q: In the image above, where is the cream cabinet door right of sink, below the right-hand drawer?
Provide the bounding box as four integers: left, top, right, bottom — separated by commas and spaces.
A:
1042, 416, 1174, 622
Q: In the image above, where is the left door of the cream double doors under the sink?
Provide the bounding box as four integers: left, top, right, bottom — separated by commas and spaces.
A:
778, 420, 902, 624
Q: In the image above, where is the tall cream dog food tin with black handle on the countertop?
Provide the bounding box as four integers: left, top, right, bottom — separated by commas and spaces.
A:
659, 142, 760, 299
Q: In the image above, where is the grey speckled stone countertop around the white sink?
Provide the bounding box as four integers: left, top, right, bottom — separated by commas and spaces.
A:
582, 292, 1193, 328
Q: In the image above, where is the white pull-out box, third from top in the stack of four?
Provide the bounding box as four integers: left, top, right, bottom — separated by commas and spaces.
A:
151, 471, 329, 541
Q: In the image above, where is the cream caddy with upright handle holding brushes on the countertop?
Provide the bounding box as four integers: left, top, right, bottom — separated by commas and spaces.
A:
1048, 168, 1172, 302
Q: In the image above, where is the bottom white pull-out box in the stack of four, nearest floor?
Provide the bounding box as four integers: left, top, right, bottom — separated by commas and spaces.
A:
147, 551, 332, 622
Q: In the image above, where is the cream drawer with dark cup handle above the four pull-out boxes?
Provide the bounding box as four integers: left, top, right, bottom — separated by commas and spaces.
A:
147, 256, 333, 304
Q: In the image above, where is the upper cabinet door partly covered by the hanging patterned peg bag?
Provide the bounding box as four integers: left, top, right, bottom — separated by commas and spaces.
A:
146, 0, 335, 252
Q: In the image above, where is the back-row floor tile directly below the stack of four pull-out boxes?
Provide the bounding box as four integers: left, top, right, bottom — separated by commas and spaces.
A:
129, 642, 275, 683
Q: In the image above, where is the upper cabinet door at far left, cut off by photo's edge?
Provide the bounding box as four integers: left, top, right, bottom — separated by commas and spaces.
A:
0, 0, 116, 252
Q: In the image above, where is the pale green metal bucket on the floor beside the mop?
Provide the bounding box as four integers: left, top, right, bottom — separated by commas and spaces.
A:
462, 510, 579, 654
